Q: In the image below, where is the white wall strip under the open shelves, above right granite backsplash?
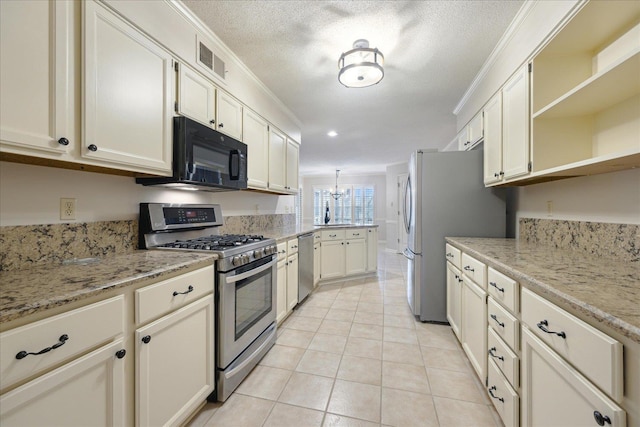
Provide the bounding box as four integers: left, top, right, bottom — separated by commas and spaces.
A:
516, 169, 640, 224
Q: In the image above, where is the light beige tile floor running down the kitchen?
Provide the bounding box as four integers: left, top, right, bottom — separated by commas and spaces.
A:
185, 251, 502, 427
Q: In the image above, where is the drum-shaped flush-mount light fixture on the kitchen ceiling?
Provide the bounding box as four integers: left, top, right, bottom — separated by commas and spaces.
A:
338, 39, 384, 87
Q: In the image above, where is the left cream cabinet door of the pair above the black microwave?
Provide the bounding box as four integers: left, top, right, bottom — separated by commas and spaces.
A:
177, 64, 216, 127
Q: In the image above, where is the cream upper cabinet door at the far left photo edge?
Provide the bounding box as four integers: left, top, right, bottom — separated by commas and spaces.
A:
0, 1, 75, 158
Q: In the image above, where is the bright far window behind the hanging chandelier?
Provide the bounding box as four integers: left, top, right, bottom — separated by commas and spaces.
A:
313, 185, 375, 224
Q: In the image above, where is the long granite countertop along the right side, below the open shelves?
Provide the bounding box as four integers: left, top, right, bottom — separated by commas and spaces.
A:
446, 237, 640, 343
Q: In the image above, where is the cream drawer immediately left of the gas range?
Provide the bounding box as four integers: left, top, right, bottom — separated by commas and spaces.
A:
135, 266, 215, 324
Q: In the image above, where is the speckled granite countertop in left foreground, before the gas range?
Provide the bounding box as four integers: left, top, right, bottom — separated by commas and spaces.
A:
0, 251, 217, 323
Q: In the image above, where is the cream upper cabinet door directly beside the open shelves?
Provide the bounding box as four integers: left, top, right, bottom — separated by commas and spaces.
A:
502, 65, 531, 179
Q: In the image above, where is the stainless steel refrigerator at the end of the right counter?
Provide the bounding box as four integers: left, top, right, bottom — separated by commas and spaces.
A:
403, 150, 506, 323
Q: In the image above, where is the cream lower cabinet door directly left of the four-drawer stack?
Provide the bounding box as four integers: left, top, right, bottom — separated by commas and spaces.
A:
462, 276, 487, 381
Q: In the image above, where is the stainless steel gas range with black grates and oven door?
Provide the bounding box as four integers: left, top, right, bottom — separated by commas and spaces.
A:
139, 203, 277, 402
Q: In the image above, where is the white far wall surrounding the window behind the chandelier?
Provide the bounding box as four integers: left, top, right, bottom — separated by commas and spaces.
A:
302, 171, 387, 242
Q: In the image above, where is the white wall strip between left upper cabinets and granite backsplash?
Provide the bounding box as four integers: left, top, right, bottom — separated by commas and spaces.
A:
0, 162, 294, 226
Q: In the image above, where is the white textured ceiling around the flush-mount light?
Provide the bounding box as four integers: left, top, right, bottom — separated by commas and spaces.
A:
183, 0, 523, 176
